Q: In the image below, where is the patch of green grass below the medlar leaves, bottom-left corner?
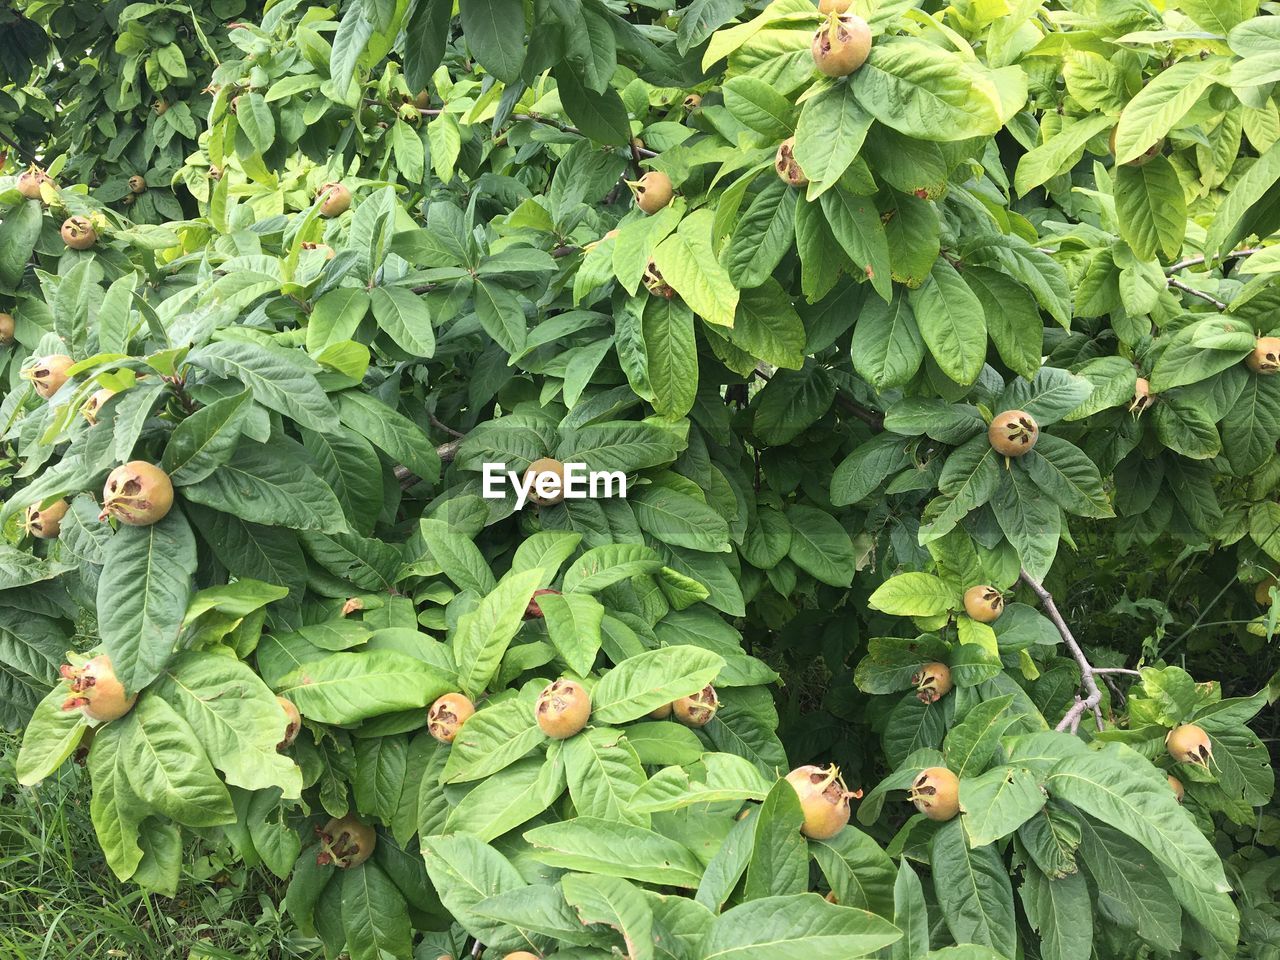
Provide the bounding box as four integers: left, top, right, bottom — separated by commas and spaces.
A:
0, 732, 323, 960
